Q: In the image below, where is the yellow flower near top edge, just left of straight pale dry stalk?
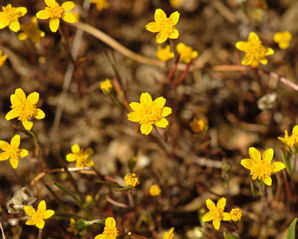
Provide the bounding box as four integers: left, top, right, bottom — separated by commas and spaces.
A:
36, 0, 77, 32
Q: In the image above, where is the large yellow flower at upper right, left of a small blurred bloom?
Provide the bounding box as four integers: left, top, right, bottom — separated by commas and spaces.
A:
236, 32, 274, 67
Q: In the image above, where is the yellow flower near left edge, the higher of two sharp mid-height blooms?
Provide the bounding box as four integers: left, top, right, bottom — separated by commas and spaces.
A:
5, 88, 45, 130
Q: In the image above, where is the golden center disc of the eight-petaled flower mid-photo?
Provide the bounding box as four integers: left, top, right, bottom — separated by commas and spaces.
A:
140, 102, 163, 124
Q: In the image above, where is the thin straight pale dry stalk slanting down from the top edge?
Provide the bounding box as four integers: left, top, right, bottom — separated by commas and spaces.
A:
50, 0, 90, 142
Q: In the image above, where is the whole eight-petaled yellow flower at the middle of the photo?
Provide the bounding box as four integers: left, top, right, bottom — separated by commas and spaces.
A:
127, 92, 172, 135
